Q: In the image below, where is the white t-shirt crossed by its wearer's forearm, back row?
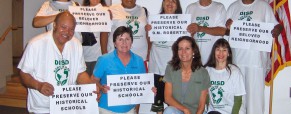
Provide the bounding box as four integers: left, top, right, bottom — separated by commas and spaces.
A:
186, 1, 226, 65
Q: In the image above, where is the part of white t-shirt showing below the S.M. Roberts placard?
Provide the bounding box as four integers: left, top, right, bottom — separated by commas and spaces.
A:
149, 41, 174, 76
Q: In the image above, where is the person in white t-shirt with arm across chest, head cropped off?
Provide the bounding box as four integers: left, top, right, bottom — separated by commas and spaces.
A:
186, 0, 226, 65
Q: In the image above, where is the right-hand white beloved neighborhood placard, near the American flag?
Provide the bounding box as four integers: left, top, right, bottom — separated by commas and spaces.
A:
229, 21, 274, 52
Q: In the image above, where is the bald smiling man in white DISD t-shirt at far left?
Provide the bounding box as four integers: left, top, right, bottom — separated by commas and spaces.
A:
18, 11, 98, 114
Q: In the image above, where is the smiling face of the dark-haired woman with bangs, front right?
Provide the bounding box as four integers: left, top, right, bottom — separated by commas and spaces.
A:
215, 46, 229, 64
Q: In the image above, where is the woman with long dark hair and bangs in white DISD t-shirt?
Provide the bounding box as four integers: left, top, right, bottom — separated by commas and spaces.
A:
205, 38, 246, 114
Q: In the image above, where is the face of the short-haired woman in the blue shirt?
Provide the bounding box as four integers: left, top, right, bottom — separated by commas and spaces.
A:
114, 33, 132, 53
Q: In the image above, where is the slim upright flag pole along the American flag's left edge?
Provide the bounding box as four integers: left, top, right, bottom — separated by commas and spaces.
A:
269, 0, 276, 114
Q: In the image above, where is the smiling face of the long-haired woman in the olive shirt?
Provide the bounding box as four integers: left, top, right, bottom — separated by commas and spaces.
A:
178, 40, 194, 63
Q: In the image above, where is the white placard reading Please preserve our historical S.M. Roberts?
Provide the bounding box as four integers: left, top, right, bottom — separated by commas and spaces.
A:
149, 14, 191, 41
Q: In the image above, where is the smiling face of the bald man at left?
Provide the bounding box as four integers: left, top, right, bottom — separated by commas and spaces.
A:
53, 13, 76, 47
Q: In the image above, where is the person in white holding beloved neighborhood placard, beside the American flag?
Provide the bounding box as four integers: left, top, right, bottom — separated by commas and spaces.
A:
226, 0, 282, 114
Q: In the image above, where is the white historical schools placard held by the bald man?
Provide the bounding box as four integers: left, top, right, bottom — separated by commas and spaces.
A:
50, 84, 99, 114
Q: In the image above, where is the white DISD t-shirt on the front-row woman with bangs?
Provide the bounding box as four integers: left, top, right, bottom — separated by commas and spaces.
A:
206, 65, 246, 114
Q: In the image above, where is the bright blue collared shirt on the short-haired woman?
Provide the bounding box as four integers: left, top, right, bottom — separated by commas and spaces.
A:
93, 50, 146, 113
